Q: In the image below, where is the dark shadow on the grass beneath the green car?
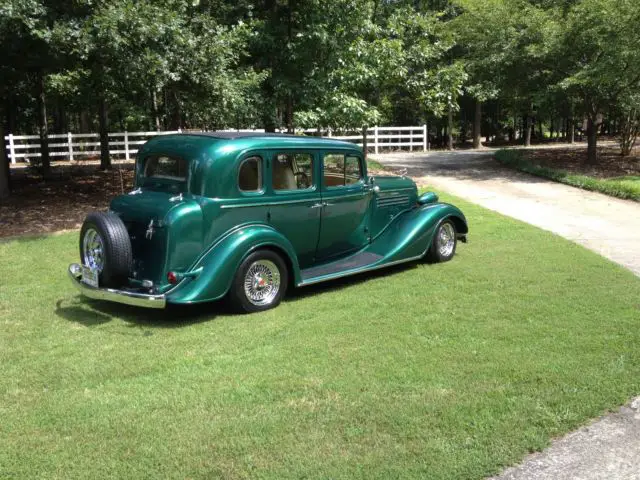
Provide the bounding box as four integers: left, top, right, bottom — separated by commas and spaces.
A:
55, 262, 419, 328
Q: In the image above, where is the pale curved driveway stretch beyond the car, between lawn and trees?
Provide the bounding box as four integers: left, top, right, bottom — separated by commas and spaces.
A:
374, 150, 640, 276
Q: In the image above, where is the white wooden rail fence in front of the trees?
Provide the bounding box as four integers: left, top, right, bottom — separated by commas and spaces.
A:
4, 125, 429, 164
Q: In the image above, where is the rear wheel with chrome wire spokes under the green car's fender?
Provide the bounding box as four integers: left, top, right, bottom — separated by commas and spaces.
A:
229, 250, 289, 313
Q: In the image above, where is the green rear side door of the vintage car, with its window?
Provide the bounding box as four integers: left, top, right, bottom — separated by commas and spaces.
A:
267, 150, 322, 268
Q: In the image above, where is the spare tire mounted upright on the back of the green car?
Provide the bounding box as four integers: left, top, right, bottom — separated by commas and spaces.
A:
80, 212, 132, 287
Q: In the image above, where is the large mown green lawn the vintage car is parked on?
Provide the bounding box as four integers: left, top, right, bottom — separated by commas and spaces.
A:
0, 195, 640, 479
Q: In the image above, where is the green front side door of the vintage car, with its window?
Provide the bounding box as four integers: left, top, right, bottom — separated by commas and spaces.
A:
316, 151, 371, 260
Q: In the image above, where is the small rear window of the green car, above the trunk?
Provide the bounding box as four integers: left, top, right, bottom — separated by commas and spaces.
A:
140, 155, 189, 192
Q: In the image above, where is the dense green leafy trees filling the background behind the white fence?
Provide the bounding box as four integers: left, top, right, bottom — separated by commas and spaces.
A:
0, 0, 640, 186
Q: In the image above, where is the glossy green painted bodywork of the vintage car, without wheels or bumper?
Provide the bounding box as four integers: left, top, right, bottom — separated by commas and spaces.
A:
106, 134, 467, 303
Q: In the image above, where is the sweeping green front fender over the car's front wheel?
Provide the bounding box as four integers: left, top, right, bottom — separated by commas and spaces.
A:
371, 203, 469, 263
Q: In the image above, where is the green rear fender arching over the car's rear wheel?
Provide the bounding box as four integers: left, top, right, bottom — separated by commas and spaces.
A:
167, 224, 300, 303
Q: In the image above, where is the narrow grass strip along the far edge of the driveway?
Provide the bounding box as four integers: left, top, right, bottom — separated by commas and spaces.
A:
495, 150, 640, 202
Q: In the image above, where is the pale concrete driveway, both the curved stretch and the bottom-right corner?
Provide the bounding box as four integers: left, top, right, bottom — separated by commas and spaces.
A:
375, 150, 640, 480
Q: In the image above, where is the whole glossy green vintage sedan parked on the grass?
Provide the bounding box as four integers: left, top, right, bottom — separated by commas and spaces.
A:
69, 132, 468, 312
